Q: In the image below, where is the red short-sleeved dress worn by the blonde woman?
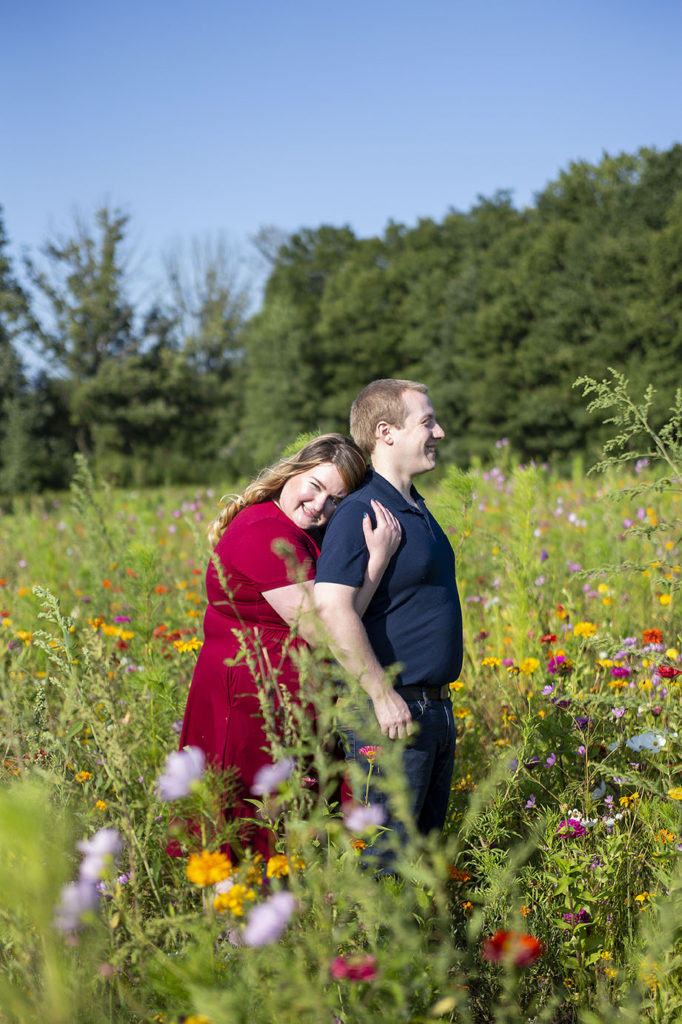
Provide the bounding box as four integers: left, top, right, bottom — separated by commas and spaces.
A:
180, 502, 319, 856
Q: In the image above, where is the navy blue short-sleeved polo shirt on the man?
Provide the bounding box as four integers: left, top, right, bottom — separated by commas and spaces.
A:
315, 470, 463, 687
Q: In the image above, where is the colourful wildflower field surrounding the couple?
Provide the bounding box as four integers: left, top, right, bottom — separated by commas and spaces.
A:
0, 397, 682, 1024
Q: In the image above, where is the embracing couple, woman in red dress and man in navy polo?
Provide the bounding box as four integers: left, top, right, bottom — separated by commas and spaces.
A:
180, 380, 462, 856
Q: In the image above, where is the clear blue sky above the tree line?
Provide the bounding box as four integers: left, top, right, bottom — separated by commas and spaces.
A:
0, 0, 682, 292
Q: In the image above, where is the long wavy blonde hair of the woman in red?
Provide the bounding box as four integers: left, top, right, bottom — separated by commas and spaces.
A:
208, 434, 367, 547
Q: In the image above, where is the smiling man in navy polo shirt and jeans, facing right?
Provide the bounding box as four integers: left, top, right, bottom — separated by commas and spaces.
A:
314, 380, 463, 835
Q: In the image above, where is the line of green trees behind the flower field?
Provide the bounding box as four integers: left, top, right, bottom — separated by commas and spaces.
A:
0, 144, 682, 495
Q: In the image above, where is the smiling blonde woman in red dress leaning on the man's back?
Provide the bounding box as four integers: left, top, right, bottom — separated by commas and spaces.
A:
180, 434, 400, 856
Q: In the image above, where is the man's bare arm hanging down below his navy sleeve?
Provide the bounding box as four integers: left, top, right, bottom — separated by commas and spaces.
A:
314, 583, 412, 739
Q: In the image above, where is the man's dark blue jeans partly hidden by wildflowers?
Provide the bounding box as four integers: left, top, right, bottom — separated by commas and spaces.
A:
342, 690, 457, 856
